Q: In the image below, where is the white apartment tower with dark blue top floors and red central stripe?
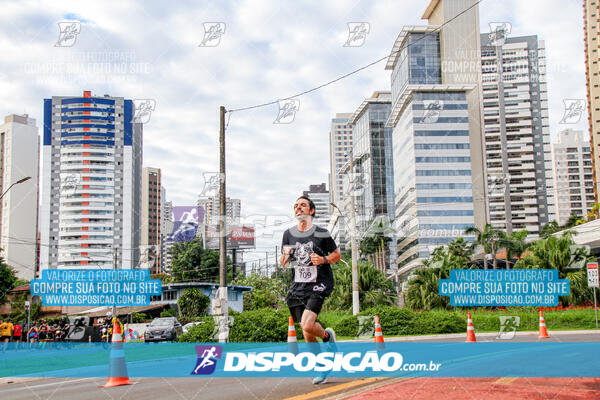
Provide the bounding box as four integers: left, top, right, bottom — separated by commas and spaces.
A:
40, 91, 142, 270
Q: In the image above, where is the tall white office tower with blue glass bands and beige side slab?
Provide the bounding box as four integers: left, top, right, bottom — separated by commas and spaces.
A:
386, 0, 486, 284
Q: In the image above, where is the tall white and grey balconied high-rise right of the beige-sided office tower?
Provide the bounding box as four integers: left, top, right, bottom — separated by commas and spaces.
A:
481, 34, 555, 238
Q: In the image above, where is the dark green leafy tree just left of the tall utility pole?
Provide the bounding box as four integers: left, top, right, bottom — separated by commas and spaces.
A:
170, 238, 219, 282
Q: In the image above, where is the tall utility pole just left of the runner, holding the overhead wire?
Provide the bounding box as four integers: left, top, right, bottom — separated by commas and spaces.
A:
215, 106, 229, 342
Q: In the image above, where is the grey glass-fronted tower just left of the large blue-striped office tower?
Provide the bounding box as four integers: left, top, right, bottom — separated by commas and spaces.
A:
350, 92, 396, 266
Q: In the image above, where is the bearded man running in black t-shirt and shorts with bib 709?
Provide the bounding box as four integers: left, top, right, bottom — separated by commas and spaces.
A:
280, 196, 342, 384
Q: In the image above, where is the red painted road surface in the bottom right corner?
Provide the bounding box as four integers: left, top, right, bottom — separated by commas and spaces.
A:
349, 378, 600, 400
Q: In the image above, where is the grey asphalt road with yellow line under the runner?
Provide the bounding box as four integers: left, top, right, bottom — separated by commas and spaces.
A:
0, 331, 600, 400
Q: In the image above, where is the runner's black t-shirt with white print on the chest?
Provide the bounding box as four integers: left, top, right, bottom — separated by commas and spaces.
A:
281, 225, 337, 297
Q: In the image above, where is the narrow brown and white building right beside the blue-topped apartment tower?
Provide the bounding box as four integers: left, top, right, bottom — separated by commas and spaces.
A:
140, 167, 162, 274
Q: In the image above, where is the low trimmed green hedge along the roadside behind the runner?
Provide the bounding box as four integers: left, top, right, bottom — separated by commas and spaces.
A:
179, 306, 595, 342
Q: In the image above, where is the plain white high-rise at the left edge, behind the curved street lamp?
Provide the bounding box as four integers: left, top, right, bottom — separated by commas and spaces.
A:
0, 114, 40, 280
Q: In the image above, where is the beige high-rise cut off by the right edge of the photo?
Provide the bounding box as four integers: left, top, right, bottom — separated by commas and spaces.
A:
575, 0, 600, 202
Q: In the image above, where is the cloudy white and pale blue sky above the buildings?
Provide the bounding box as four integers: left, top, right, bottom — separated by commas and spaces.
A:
0, 0, 589, 268
